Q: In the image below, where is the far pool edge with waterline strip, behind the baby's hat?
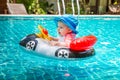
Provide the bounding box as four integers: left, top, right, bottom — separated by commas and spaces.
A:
0, 14, 120, 19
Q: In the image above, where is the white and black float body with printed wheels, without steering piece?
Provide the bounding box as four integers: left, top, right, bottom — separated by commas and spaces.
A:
20, 34, 95, 58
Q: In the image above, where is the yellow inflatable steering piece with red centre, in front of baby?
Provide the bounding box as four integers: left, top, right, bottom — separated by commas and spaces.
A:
36, 25, 51, 40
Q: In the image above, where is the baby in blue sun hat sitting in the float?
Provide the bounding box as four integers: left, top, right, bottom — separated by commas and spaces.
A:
50, 15, 78, 47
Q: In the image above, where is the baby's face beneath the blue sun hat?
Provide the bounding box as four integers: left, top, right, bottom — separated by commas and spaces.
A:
58, 22, 72, 36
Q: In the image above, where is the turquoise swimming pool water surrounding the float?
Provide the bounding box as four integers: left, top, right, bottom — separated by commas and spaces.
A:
0, 16, 120, 80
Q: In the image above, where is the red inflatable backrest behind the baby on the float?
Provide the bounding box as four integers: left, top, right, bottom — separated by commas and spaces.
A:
70, 35, 97, 51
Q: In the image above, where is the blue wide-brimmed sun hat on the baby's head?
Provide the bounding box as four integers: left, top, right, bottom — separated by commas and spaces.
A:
54, 15, 78, 34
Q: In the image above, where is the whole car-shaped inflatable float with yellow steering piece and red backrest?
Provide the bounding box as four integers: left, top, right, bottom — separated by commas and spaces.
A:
20, 26, 97, 58
